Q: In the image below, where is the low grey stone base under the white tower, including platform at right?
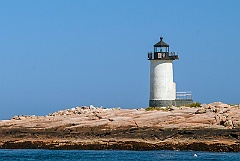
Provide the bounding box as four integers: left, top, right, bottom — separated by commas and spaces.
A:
149, 99, 193, 107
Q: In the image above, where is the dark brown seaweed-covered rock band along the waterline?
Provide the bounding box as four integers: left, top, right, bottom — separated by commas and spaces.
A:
0, 140, 240, 152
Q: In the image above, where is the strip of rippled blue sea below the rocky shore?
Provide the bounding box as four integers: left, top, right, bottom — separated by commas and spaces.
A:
0, 149, 240, 161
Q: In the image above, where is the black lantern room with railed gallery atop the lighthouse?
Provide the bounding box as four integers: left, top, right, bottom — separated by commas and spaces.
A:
148, 37, 178, 60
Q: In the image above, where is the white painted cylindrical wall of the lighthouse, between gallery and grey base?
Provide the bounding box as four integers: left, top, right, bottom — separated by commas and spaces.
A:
150, 60, 176, 100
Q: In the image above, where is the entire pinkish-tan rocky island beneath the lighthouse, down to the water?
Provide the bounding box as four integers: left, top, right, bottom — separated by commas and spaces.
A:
0, 102, 240, 152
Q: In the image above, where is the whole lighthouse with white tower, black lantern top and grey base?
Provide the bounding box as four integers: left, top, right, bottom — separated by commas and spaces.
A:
148, 37, 178, 107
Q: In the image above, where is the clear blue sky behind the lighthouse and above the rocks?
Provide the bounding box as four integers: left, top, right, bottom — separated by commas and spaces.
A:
0, 0, 240, 119
